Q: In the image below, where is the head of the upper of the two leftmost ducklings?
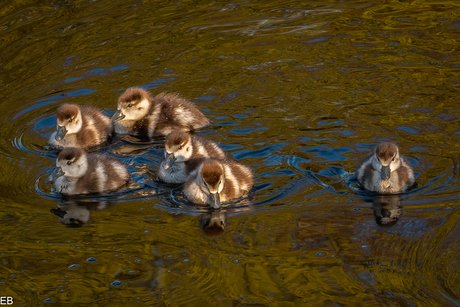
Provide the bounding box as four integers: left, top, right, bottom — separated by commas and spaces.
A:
55, 103, 83, 141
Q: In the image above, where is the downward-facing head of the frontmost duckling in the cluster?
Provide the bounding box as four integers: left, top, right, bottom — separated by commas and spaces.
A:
198, 159, 225, 209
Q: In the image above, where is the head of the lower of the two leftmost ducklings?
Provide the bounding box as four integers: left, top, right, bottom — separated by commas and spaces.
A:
51, 147, 88, 180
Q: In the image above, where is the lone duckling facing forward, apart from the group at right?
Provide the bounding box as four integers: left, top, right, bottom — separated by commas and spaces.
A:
356, 143, 415, 194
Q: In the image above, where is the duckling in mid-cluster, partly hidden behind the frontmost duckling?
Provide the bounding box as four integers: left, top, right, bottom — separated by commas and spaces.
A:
158, 131, 226, 183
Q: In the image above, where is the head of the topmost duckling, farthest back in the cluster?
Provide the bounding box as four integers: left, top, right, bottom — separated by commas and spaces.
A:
112, 87, 152, 122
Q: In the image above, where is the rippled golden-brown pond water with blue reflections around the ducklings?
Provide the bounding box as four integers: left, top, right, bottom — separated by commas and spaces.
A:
0, 0, 460, 306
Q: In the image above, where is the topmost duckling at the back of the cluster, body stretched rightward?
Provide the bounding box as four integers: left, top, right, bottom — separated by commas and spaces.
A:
112, 88, 209, 137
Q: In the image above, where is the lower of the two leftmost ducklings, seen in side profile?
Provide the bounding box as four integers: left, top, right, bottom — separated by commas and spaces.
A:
51, 147, 129, 195
